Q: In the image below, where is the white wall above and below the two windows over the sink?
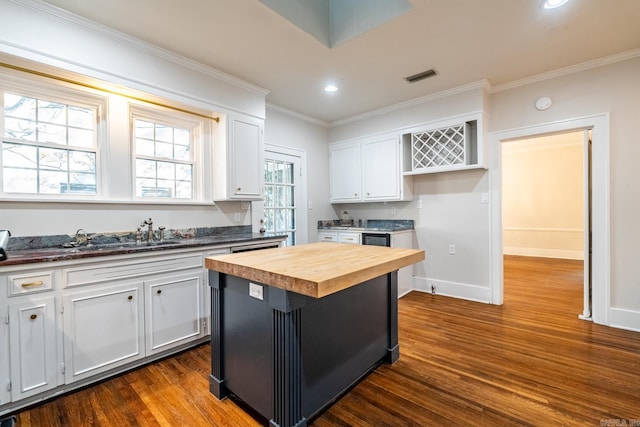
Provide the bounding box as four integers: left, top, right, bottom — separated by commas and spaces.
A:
0, 1, 267, 236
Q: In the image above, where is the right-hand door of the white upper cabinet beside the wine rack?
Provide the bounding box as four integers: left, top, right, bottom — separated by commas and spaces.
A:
362, 137, 402, 201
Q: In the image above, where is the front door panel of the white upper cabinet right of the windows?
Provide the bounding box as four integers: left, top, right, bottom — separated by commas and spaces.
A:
229, 116, 264, 200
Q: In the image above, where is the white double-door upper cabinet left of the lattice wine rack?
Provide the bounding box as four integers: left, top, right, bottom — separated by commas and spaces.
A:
329, 135, 412, 203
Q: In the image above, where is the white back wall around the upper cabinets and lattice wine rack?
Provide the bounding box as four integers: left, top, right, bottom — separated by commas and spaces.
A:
330, 82, 491, 302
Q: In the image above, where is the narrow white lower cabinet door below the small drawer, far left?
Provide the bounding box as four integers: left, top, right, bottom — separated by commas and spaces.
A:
9, 295, 58, 401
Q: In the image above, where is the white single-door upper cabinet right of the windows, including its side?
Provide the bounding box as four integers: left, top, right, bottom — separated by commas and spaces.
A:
213, 114, 264, 201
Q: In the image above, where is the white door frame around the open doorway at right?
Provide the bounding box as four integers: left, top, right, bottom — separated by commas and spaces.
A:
488, 113, 611, 325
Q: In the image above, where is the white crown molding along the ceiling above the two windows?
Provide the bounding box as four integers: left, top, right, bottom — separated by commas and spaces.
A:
9, 0, 270, 96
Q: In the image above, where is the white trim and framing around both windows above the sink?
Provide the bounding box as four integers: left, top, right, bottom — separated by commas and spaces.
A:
0, 66, 218, 206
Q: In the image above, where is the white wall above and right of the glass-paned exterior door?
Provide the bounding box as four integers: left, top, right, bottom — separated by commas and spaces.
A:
265, 107, 335, 242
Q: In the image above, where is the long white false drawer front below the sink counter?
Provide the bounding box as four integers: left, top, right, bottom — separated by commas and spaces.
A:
63, 253, 202, 287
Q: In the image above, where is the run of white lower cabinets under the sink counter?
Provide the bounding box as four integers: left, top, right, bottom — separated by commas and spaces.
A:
0, 239, 280, 418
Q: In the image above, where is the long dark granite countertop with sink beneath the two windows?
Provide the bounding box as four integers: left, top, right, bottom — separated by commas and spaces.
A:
0, 227, 286, 268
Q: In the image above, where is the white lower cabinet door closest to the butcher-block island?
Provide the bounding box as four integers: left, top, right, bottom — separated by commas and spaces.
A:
145, 270, 204, 355
